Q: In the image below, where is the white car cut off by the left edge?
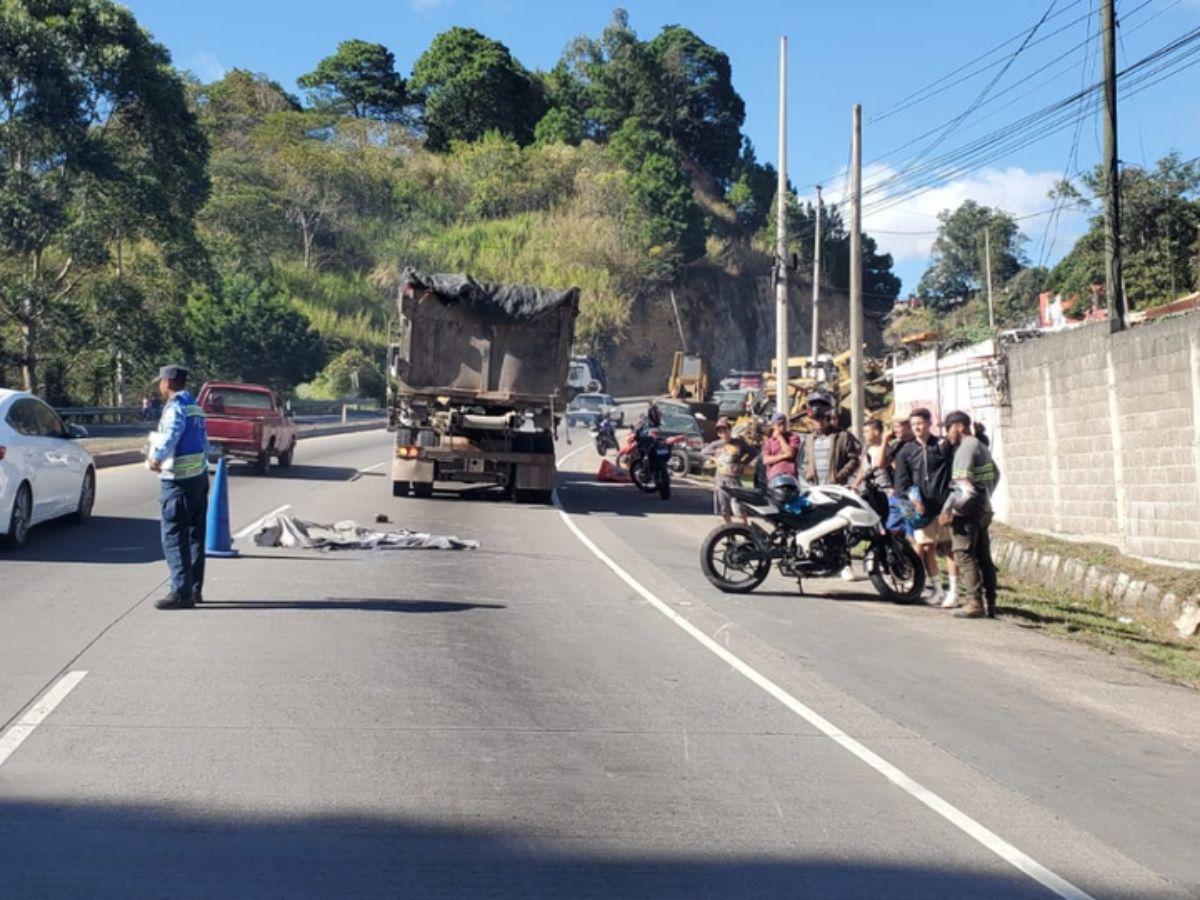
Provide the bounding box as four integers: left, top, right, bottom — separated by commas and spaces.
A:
0, 388, 96, 547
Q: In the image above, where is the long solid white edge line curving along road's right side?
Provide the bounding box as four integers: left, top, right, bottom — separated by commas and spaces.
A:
554, 496, 1092, 900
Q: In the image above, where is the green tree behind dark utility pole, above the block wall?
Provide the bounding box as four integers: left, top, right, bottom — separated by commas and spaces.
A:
1049, 152, 1200, 308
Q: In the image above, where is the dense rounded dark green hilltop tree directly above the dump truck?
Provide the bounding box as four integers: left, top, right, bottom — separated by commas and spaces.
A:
409, 28, 546, 150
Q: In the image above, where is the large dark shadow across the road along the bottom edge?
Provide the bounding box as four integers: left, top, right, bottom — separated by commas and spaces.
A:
0, 801, 1060, 900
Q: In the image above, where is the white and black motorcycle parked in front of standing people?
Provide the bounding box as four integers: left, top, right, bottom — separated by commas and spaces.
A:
700, 475, 925, 604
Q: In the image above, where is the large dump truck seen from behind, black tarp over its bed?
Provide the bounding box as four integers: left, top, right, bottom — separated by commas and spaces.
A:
388, 269, 580, 503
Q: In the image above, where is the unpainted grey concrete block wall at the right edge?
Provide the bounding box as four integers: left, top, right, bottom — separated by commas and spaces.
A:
1001, 313, 1200, 563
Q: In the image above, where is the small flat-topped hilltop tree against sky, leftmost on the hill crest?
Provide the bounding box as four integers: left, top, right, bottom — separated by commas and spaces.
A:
296, 40, 408, 121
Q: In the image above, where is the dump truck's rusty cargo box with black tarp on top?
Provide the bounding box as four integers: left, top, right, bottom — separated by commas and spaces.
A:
395, 269, 580, 398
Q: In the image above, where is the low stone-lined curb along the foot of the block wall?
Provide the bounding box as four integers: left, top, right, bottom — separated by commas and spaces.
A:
991, 538, 1200, 637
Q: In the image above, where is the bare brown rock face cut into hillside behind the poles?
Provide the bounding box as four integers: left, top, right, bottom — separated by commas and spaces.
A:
605, 265, 890, 396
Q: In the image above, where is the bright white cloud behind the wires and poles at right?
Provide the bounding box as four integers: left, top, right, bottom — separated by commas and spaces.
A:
802, 164, 1089, 273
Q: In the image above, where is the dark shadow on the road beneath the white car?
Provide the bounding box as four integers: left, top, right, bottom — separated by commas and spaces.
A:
0, 516, 162, 563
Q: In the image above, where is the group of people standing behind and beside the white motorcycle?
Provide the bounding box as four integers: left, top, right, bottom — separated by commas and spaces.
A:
704, 397, 1000, 618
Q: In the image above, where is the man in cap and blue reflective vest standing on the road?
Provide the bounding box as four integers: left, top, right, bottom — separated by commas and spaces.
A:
146, 366, 209, 610
